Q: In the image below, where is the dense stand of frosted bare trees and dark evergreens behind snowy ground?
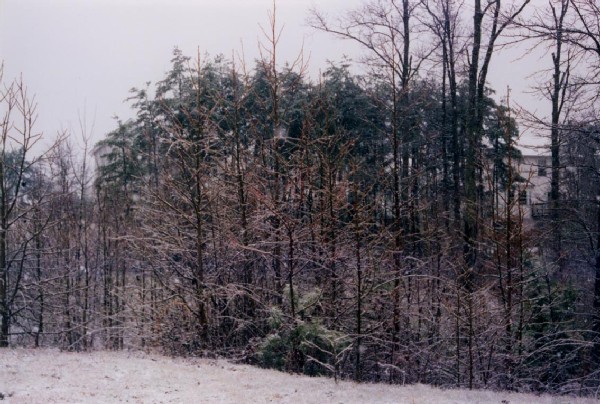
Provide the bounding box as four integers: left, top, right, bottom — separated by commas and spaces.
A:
0, 0, 600, 395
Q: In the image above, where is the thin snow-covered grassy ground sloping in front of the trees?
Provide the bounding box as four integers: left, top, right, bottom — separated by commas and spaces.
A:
0, 349, 600, 404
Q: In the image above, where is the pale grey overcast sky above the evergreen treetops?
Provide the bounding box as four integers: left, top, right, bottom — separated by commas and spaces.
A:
0, 0, 539, 152
